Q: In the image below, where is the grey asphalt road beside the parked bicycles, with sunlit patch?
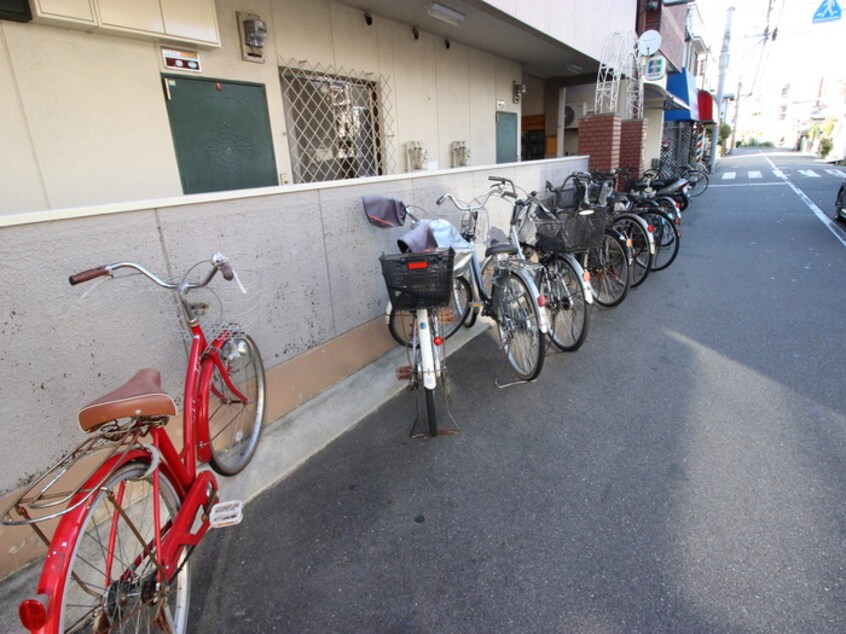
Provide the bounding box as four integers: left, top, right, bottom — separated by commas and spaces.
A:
190, 151, 846, 634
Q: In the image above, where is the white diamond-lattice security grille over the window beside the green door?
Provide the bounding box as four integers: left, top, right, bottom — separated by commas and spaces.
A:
279, 61, 396, 183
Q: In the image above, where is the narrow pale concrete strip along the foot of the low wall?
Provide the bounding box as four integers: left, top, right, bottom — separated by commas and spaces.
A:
0, 319, 490, 633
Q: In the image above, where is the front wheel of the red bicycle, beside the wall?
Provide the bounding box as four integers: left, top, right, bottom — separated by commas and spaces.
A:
208, 334, 265, 476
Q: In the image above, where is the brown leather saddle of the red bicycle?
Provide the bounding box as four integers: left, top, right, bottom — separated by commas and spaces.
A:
77, 368, 176, 431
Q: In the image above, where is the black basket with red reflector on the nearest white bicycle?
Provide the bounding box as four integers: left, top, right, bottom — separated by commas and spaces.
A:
379, 249, 455, 310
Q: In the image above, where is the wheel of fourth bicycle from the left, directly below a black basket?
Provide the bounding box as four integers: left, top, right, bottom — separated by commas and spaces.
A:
545, 256, 591, 352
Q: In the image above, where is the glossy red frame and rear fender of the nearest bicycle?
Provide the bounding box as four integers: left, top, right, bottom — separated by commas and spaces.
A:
17, 260, 255, 634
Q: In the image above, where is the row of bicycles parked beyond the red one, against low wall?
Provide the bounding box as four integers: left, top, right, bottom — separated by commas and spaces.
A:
362, 164, 707, 437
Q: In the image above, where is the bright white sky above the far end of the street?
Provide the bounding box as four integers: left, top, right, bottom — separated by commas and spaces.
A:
696, 0, 846, 95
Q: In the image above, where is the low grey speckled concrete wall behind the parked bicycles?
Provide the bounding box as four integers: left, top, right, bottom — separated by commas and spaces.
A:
0, 157, 587, 577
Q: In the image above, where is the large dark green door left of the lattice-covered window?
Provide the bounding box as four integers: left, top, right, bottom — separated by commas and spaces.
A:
163, 75, 279, 194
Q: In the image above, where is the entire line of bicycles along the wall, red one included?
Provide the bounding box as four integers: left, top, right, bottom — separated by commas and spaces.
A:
0, 162, 704, 634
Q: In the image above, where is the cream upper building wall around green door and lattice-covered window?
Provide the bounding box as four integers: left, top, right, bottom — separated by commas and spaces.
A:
0, 0, 521, 215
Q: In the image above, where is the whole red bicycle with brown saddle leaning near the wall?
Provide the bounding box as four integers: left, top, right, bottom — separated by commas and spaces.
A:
2, 253, 265, 634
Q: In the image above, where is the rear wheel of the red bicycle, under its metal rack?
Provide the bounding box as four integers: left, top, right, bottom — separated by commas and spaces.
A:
57, 461, 191, 634
